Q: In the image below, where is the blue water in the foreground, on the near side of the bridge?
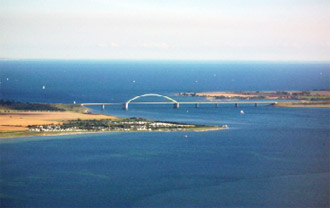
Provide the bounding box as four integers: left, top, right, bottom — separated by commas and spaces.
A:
0, 106, 329, 206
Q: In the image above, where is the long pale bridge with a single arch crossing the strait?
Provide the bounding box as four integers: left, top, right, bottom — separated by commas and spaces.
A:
80, 94, 276, 110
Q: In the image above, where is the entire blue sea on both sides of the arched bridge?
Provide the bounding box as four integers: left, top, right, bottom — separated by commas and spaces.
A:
0, 60, 330, 207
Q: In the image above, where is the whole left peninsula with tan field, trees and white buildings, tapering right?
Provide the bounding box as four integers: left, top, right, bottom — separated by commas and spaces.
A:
0, 100, 228, 138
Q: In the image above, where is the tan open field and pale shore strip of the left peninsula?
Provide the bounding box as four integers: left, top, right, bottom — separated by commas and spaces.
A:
0, 111, 228, 139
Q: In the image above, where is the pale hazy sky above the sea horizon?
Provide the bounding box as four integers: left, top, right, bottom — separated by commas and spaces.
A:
0, 0, 330, 61
